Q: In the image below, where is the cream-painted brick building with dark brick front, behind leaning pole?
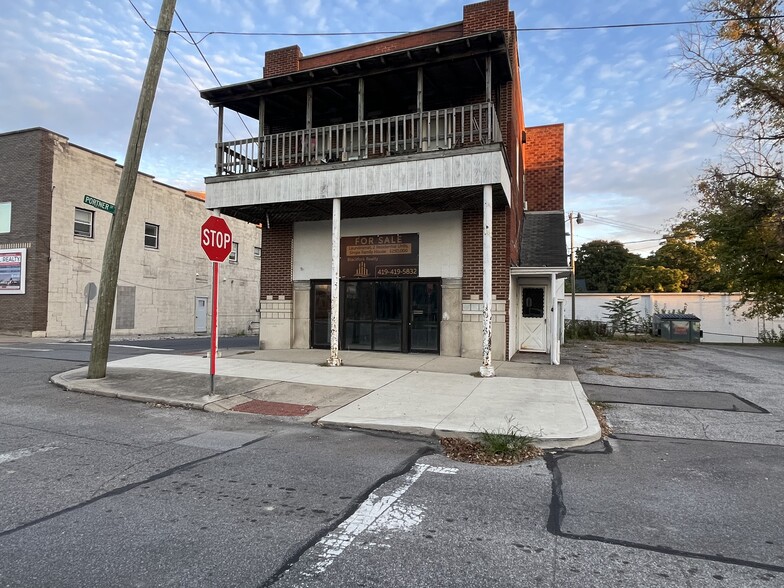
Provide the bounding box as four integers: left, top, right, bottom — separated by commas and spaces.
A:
0, 128, 260, 337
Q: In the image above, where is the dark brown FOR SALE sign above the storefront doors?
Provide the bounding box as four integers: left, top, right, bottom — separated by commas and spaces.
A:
340, 233, 419, 279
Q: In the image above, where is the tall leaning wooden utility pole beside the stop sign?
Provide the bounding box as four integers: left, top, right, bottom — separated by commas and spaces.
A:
87, 0, 177, 378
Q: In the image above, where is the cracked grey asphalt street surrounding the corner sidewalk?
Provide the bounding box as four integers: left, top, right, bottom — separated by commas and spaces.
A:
0, 338, 784, 588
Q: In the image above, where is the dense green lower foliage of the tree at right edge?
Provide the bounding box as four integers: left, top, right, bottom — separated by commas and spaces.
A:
690, 168, 784, 316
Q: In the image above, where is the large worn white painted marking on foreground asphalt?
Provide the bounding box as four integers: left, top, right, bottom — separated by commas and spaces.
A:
294, 463, 457, 578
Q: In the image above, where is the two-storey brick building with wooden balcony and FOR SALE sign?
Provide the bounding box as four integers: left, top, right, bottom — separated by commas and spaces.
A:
202, 0, 568, 368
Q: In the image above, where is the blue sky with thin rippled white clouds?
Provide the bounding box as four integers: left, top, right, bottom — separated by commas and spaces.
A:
0, 0, 729, 255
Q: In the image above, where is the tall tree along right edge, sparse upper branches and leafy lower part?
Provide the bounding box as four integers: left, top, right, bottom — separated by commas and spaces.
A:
680, 0, 784, 316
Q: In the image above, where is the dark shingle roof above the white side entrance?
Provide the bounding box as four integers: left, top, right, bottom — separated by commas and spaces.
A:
520, 210, 569, 267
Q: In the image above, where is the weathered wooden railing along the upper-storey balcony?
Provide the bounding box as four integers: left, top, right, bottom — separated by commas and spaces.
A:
216, 102, 502, 176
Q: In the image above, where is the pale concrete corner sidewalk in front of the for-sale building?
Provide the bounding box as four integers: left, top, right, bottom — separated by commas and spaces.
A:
52, 350, 601, 448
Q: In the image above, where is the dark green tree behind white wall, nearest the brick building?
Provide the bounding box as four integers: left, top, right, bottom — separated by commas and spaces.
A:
575, 240, 642, 292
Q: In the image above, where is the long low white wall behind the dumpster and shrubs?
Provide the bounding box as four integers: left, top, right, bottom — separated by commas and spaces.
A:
565, 292, 784, 343
